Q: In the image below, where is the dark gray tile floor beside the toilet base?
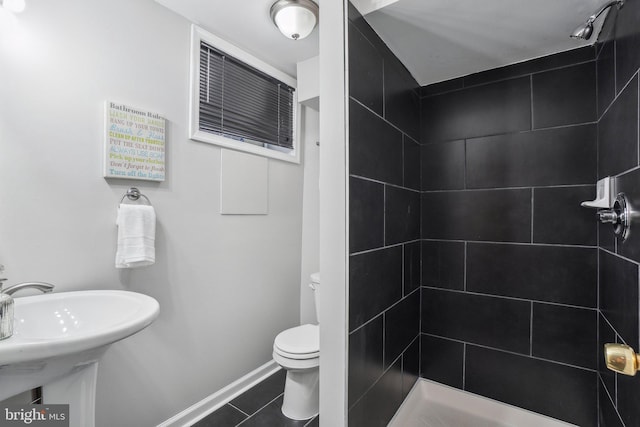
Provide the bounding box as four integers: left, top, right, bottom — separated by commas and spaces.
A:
192, 369, 320, 427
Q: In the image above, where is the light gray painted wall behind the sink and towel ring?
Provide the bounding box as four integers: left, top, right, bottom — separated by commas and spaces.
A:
0, 0, 303, 427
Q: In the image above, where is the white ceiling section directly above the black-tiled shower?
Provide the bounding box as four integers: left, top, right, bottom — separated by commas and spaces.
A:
366, 0, 605, 85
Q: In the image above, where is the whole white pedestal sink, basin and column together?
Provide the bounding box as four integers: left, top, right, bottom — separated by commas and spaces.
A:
0, 291, 159, 427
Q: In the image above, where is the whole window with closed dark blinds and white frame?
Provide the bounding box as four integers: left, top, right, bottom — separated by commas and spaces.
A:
189, 25, 300, 163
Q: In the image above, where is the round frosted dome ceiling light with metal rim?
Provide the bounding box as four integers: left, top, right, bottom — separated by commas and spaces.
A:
272, 0, 319, 40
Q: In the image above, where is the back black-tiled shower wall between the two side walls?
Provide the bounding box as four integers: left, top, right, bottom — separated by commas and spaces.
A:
421, 47, 598, 426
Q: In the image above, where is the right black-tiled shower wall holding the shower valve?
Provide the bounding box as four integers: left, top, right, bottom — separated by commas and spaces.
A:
597, 0, 640, 427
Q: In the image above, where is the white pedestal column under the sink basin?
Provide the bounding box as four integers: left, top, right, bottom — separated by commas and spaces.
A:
42, 361, 98, 427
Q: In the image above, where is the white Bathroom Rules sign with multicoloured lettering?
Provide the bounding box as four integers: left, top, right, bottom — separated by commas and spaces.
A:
104, 101, 165, 181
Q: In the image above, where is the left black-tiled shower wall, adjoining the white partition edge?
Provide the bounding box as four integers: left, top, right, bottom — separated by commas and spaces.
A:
348, 7, 420, 427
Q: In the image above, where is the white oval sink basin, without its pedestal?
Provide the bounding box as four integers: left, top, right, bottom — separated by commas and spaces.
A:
0, 291, 160, 366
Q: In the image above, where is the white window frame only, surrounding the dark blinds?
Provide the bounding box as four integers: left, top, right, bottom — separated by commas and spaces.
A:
189, 24, 300, 164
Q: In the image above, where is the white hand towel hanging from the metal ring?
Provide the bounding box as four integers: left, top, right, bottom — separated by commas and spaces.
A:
116, 204, 156, 268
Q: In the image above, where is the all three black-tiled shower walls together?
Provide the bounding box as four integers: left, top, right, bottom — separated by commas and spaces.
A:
349, 0, 640, 427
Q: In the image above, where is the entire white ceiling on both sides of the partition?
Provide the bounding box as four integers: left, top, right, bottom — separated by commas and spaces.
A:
156, 0, 605, 85
